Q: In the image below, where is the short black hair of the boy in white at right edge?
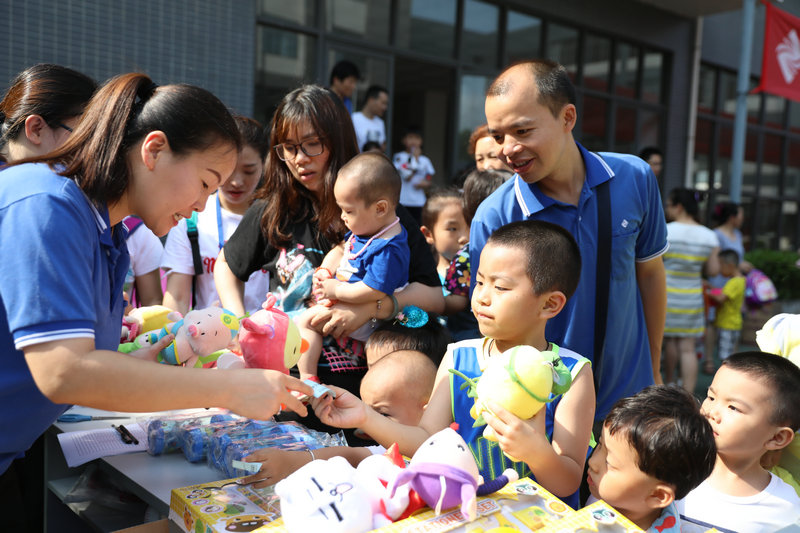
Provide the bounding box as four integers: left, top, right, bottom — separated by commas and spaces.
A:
722, 351, 800, 431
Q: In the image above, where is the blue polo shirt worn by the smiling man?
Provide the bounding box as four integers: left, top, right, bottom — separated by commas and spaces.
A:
469, 144, 668, 419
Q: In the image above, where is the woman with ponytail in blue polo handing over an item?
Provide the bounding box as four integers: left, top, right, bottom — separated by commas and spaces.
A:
0, 74, 312, 473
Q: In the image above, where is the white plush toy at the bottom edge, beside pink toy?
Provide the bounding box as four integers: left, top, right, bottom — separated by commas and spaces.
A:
275, 457, 375, 533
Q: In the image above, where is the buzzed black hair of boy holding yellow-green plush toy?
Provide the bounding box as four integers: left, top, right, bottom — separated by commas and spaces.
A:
486, 220, 581, 298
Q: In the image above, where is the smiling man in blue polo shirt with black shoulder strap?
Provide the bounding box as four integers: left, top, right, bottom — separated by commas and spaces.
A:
470, 61, 667, 420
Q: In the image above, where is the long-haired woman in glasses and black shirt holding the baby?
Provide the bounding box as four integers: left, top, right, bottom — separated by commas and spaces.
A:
214, 85, 444, 426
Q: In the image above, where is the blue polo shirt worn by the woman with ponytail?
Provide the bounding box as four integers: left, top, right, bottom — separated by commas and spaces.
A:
0, 164, 130, 473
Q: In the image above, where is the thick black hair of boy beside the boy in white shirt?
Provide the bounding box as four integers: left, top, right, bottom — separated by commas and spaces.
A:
605, 385, 717, 500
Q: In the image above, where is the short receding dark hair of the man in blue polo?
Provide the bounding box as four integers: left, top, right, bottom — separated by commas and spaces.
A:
486, 59, 576, 118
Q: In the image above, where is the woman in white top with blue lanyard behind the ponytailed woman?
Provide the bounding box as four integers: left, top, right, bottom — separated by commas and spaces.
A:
161, 116, 268, 314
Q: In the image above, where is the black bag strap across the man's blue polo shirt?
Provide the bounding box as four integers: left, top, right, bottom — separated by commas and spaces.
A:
592, 179, 611, 393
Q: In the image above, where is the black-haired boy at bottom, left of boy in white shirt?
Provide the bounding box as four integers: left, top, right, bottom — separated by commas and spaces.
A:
587, 385, 717, 533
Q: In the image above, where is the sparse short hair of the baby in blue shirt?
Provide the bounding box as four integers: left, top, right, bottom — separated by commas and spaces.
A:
339, 152, 403, 208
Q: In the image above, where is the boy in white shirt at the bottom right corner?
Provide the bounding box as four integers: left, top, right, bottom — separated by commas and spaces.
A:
677, 352, 800, 533
